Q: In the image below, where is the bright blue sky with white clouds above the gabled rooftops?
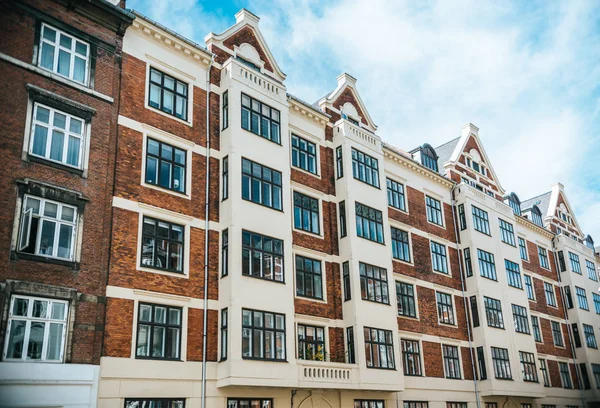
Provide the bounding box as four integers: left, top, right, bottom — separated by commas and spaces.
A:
127, 0, 600, 245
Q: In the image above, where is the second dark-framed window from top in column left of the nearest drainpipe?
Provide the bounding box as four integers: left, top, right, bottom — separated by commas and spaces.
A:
146, 138, 186, 193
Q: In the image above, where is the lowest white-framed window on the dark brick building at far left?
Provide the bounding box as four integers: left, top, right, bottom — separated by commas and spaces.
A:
4, 295, 69, 362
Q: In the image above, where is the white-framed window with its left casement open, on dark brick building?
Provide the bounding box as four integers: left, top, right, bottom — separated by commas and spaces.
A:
18, 195, 77, 260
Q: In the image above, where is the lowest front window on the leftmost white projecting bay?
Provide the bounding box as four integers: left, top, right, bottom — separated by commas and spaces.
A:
242, 309, 286, 361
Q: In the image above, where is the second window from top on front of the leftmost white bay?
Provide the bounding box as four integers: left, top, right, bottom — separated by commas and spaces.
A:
242, 158, 282, 210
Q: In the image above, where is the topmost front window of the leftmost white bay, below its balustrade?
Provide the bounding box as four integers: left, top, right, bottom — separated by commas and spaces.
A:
242, 94, 281, 144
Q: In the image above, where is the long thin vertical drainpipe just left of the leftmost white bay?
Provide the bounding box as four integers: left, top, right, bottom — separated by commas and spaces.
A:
200, 54, 215, 408
